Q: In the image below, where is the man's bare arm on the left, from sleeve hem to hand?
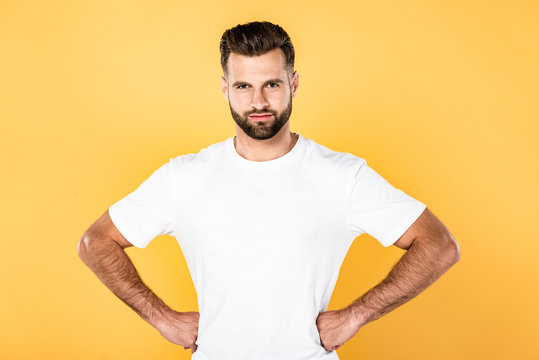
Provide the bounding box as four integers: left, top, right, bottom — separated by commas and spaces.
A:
77, 210, 198, 352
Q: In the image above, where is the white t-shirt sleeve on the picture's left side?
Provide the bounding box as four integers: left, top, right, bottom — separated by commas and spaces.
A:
109, 158, 174, 248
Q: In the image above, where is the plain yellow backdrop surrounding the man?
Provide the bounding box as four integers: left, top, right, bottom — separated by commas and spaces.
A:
0, 0, 539, 360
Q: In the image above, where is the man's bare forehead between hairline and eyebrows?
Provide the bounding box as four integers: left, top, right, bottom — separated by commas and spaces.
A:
227, 48, 286, 81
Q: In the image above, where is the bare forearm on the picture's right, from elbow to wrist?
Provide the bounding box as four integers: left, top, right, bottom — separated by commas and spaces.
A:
349, 239, 459, 328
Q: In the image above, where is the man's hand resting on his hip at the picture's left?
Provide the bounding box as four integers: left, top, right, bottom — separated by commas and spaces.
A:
155, 310, 200, 353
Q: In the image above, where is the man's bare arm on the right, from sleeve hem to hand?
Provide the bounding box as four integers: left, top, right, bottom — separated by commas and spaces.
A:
317, 208, 460, 351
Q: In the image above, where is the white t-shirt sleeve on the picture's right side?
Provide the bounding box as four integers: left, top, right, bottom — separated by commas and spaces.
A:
347, 159, 427, 247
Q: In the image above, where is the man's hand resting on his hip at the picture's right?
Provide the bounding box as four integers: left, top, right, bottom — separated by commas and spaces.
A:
316, 307, 360, 351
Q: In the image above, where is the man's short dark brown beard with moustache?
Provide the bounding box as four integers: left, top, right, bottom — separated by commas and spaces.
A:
228, 95, 292, 140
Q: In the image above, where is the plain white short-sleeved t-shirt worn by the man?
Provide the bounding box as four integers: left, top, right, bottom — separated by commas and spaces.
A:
109, 134, 426, 360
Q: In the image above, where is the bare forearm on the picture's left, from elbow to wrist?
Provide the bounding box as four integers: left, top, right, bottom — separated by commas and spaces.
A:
79, 240, 171, 327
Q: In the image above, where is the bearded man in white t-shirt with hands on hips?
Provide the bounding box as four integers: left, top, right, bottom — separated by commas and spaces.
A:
78, 22, 460, 360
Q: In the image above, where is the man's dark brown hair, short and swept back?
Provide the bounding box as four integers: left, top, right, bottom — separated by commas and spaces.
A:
219, 21, 294, 77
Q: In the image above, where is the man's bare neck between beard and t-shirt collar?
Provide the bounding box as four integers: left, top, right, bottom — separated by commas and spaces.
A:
234, 129, 299, 161
